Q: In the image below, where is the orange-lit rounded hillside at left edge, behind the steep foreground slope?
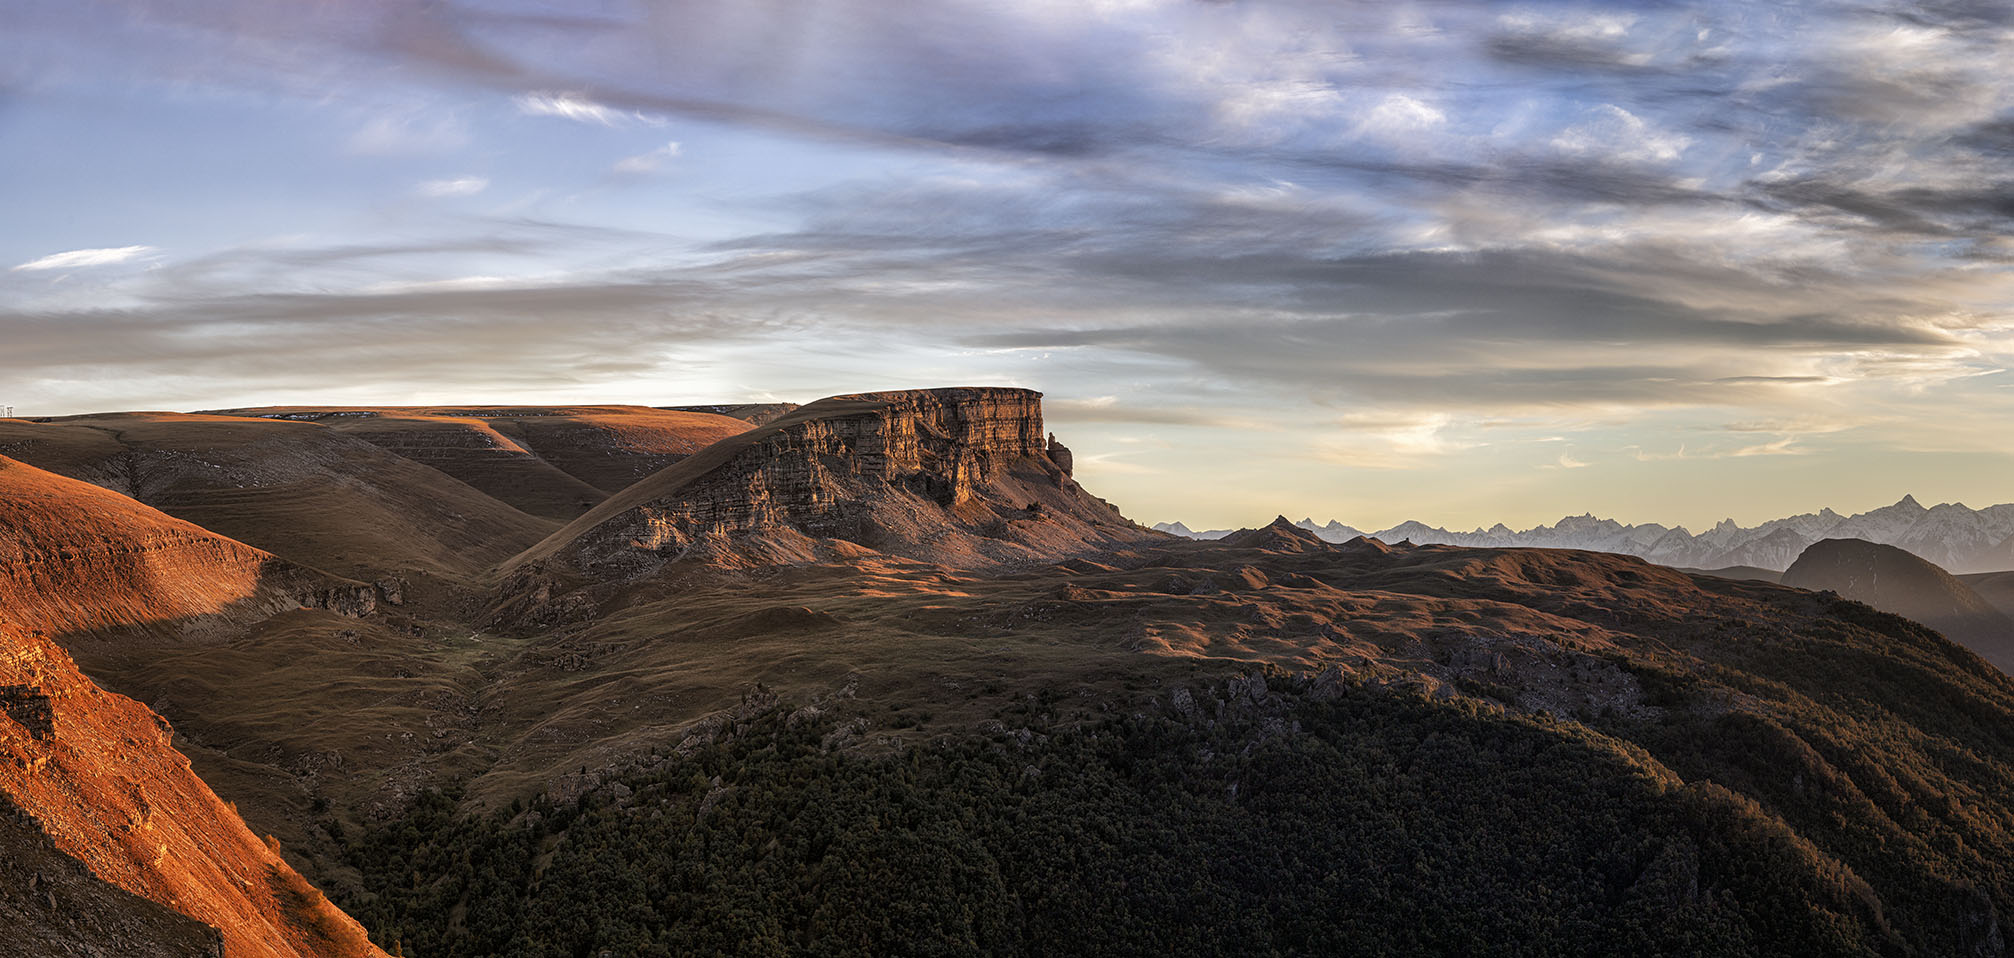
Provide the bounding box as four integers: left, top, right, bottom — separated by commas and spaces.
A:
0, 457, 379, 638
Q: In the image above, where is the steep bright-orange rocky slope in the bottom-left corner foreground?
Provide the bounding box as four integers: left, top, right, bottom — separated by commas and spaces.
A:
0, 628, 383, 958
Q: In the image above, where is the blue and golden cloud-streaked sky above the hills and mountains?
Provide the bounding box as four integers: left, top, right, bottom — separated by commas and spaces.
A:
0, 0, 2014, 531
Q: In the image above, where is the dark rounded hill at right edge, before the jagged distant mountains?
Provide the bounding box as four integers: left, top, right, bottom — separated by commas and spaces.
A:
1782, 539, 2014, 672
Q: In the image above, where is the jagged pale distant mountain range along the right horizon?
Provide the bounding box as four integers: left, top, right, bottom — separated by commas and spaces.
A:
1154, 495, 2014, 574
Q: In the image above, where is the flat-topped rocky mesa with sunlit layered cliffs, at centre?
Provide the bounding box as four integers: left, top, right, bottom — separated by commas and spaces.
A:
512, 386, 1156, 599
